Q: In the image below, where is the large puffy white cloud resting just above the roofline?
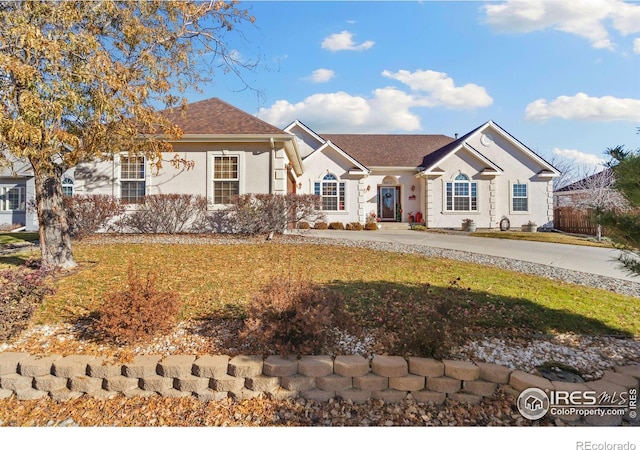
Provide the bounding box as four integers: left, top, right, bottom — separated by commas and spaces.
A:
258, 88, 420, 133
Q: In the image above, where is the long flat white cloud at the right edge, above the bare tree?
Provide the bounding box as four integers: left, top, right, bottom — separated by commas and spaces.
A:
525, 92, 640, 122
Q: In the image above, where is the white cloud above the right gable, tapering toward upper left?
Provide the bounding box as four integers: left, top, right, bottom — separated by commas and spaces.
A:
382, 70, 493, 109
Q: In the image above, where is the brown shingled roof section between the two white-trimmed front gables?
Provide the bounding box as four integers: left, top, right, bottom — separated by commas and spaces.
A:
321, 134, 453, 167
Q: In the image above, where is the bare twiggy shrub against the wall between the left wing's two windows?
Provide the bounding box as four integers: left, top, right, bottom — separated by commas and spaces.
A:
119, 194, 207, 234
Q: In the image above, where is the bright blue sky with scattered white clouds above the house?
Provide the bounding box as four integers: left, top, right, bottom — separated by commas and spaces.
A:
189, 0, 640, 172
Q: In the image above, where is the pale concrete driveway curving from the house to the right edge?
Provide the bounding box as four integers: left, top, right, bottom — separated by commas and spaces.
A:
300, 230, 640, 283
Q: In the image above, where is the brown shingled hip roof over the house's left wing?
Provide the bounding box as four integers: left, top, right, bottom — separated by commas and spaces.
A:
162, 98, 288, 135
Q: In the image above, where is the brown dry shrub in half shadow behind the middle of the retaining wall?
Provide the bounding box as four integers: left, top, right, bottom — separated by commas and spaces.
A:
241, 276, 353, 355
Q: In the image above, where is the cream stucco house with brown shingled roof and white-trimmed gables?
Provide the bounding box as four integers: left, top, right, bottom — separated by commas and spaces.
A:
5, 98, 559, 232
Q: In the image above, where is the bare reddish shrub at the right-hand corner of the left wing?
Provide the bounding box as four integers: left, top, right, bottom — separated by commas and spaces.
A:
227, 194, 324, 234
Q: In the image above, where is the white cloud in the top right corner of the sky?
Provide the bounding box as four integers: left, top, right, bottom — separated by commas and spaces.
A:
483, 0, 640, 49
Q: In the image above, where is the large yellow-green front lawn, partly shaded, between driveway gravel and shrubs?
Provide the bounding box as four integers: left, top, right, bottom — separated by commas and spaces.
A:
18, 243, 640, 336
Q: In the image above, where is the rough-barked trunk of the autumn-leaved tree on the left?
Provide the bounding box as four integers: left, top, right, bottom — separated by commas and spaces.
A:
34, 165, 76, 269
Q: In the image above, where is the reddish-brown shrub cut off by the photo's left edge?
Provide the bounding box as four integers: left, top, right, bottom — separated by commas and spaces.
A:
0, 261, 54, 341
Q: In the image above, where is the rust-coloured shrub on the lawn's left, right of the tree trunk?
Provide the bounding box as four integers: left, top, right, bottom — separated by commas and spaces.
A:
96, 264, 181, 344
